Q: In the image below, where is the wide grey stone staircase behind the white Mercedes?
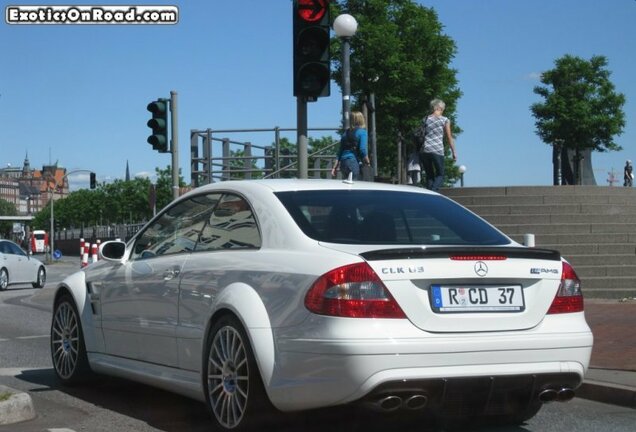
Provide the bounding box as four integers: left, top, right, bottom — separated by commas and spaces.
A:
441, 186, 636, 298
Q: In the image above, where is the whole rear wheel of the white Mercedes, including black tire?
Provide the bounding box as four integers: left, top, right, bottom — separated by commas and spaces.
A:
203, 315, 276, 431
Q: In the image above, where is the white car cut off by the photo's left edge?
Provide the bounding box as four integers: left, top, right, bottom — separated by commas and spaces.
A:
0, 240, 46, 291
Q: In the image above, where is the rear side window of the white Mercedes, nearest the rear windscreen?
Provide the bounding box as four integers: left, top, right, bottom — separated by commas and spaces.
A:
196, 194, 261, 251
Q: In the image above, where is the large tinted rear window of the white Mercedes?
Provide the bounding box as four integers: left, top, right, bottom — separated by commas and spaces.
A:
276, 190, 510, 245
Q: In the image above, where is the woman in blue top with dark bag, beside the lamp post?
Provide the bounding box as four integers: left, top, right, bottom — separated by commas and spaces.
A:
331, 111, 369, 180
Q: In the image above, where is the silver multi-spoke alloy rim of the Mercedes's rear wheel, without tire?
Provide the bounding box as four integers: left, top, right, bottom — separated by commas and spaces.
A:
207, 326, 250, 429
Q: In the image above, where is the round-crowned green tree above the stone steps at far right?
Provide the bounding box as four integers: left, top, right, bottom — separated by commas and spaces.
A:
530, 55, 625, 184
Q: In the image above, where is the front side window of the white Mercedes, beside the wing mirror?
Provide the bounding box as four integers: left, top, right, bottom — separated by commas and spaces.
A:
131, 194, 221, 259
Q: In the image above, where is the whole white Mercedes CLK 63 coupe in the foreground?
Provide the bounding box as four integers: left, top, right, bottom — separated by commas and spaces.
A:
51, 180, 593, 430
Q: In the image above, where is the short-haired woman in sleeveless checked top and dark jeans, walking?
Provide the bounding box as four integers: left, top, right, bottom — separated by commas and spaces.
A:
420, 99, 457, 191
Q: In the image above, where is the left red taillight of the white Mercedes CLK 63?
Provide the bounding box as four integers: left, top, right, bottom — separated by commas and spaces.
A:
305, 263, 406, 318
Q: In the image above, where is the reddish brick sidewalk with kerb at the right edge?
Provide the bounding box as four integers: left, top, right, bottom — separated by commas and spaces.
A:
576, 299, 636, 408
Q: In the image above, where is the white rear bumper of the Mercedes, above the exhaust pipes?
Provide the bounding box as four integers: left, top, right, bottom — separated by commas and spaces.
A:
267, 320, 593, 411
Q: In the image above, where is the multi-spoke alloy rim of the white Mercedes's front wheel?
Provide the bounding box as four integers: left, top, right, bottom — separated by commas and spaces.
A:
51, 301, 80, 379
